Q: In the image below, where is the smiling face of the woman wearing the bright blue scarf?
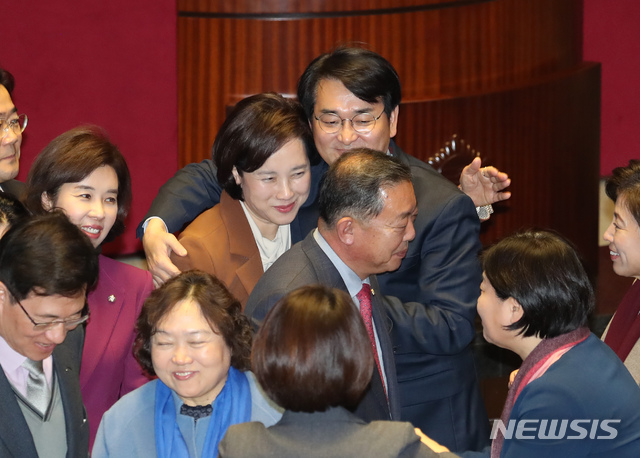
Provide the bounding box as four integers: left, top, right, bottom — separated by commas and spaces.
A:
151, 299, 231, 406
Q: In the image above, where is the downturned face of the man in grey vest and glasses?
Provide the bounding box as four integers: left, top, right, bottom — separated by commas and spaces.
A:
0, 283, 85, 361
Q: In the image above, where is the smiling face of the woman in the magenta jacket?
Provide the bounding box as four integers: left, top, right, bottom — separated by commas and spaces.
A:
42, 165, 118, 247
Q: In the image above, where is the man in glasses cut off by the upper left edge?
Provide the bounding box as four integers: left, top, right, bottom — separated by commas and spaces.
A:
0, 68, 27, 197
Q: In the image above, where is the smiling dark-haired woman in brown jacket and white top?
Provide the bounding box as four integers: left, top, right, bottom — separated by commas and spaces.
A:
171, 93, 313, 307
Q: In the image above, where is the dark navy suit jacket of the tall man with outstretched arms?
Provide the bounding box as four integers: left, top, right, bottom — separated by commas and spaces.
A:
138, 141, 489, 450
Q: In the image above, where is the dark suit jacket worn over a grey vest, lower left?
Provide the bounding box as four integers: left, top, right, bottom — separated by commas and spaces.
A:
0, 326, 89, 458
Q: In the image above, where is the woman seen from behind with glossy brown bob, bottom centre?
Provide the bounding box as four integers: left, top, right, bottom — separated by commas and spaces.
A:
220, 285, 455, 458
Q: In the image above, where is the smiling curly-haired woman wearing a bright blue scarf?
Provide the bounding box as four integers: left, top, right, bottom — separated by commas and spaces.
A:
92, 271, 281, 458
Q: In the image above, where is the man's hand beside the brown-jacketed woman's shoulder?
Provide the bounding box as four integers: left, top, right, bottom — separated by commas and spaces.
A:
142, 218, 187, 288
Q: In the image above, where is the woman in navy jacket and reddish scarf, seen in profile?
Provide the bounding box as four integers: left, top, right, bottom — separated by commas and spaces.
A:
464, 230, 640, 458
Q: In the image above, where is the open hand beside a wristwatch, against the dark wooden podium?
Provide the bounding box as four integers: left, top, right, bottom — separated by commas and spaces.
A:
460, 157, 511, 207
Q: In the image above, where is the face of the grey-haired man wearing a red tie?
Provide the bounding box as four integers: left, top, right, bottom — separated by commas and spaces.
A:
348, 182, 418, 279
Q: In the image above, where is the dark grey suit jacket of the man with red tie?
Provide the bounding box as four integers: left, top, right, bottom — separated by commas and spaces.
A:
245, 233, 400, 421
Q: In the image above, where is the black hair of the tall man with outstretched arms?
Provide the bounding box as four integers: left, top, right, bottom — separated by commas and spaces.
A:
298, 46, 402, 120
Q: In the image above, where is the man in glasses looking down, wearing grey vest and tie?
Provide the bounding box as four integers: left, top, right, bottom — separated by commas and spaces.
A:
0, 213, 98, 458
